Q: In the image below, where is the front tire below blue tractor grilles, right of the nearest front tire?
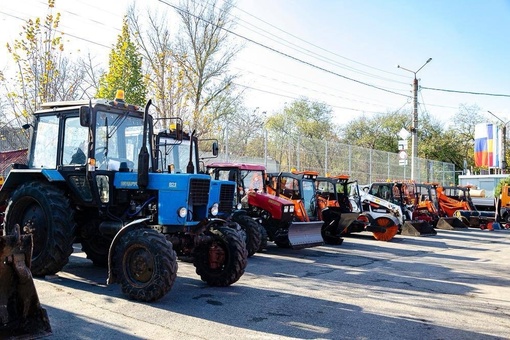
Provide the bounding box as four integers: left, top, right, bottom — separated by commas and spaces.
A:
193, 227, 248, 287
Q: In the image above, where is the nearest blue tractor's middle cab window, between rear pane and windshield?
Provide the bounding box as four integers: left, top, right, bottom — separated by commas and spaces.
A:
62, 117, 88, 164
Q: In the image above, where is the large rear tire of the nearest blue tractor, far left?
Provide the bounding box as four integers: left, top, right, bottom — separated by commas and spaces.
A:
5, 182, 76, 276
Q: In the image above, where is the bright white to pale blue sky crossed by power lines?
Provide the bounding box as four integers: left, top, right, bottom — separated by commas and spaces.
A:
0, 0, 510, 126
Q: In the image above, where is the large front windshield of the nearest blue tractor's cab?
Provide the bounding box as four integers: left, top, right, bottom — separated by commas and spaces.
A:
95, 112, 143, 171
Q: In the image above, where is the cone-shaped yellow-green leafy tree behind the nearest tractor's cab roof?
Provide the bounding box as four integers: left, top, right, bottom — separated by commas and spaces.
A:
97, 17, 147, 105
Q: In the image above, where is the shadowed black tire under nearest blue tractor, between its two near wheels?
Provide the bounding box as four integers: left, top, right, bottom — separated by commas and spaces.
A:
81, 221, 112, 267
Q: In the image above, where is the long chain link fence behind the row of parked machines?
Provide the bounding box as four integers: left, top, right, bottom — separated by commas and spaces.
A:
210, 132, 455, 185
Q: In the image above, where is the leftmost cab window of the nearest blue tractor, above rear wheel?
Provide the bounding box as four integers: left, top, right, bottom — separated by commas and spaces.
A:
31, 115, 59, 169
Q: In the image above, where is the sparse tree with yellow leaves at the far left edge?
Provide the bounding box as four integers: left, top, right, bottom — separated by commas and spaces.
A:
0, 0, 83, 147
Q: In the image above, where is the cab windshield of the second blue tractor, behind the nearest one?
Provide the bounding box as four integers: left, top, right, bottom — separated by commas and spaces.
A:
157, 138, 194, 173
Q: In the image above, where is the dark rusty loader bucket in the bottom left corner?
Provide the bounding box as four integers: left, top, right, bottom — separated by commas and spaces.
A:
0, 225, 52, 339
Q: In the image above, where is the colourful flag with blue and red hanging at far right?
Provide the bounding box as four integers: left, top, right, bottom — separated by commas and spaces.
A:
475, 123, 501, 167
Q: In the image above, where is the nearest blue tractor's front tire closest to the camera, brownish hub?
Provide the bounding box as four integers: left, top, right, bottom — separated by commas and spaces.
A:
112, 228, 177, 302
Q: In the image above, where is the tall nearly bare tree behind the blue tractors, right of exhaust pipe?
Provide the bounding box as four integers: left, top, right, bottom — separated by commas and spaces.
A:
176, 0, 240, 135
